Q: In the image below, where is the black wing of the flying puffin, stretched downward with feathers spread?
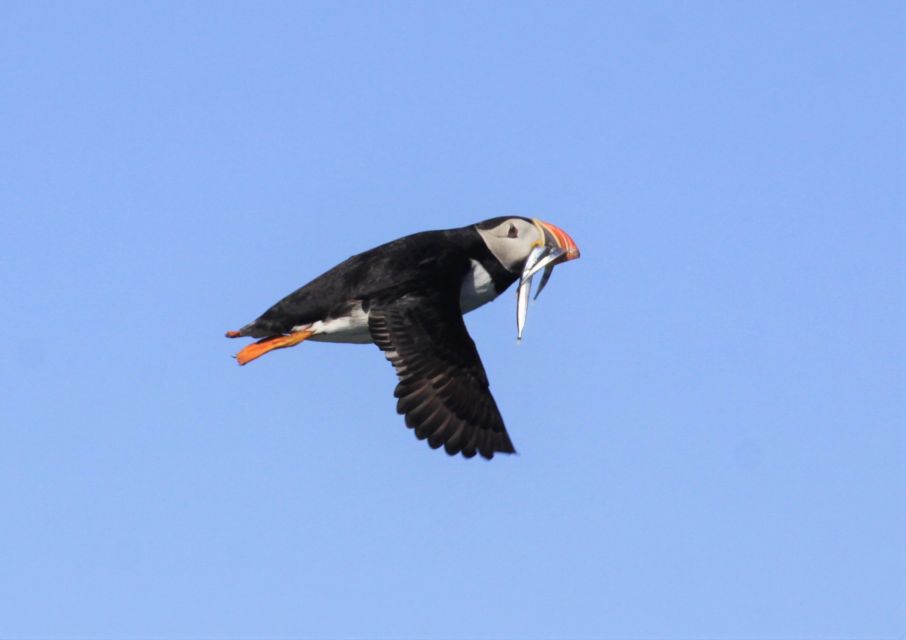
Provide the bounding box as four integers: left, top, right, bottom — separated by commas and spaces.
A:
368, 288, 515, 460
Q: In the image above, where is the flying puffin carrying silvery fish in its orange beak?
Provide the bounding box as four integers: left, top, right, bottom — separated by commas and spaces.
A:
226, 216, 579, 460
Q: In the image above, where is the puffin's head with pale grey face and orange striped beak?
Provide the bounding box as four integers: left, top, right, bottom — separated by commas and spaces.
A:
475, 216, 579, 278
